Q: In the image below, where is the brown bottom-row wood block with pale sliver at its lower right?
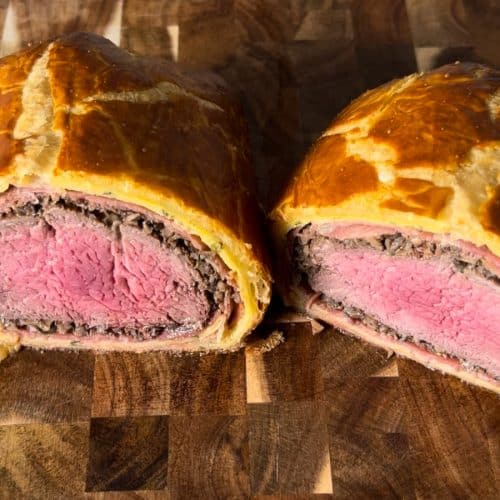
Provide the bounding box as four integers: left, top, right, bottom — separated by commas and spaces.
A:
248, 402, 331, 495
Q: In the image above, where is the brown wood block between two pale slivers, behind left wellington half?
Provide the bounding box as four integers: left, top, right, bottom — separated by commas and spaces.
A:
11, 0, 117, 44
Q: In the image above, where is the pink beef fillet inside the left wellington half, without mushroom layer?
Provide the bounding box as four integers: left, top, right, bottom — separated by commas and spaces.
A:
0, 201, 210, 330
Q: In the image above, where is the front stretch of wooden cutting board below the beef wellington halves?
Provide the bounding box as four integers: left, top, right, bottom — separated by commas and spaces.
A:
0, 323, 500, 499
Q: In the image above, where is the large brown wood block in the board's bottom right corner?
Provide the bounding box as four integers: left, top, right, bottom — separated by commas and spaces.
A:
402, 372, 500, 498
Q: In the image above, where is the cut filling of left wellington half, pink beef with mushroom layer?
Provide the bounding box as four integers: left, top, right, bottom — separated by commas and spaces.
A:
0, 189, 239, 350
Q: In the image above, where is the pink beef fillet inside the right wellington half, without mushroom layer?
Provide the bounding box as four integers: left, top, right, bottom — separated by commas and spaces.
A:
298, 225, 500, 377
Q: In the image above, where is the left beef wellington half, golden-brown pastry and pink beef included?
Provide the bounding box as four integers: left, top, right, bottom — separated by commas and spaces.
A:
0, 33, 270, 354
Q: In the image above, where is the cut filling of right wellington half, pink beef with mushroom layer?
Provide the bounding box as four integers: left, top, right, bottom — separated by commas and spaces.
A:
290, 224, 500, 378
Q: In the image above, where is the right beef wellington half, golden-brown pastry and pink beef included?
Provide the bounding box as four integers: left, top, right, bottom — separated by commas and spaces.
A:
271, 64, 500, 392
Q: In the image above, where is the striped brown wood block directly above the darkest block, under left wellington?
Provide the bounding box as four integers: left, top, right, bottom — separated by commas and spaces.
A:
92, 352, 171, 417
